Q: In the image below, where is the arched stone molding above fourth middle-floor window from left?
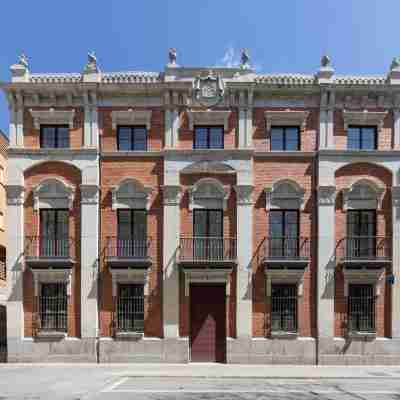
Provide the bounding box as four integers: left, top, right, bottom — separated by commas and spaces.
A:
264, 179, 305, 210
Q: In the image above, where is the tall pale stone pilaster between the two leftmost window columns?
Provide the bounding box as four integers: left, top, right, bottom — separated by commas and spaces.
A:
80, 184, 99, 339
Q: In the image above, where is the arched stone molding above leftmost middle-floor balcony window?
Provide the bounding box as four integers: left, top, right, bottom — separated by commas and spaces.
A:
33, 177, 75, 211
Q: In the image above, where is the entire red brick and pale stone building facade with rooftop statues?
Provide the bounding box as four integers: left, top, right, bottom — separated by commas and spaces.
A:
1, 49, 400, 364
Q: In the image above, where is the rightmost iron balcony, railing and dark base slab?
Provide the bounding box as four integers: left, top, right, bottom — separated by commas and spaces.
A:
336, 236, 392, 269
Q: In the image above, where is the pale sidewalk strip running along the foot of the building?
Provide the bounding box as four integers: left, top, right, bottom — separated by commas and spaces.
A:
0, 363, 400, 379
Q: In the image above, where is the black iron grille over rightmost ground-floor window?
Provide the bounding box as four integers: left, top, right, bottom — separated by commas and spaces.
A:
348, 284, 375, 333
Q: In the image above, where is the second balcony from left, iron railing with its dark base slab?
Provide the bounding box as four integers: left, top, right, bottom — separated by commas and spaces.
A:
105, 236, 151, 269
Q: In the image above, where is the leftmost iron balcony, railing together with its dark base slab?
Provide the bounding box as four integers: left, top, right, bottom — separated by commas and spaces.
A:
25, 236, 75, 269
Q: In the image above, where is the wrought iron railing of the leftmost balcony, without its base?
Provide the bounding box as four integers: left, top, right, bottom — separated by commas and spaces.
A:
25, 236, 75, 262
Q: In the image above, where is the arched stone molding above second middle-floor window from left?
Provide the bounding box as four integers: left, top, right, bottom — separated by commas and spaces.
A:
111, 178, 153, 210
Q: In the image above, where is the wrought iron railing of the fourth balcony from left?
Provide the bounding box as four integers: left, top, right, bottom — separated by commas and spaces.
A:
264, 236, 310, 263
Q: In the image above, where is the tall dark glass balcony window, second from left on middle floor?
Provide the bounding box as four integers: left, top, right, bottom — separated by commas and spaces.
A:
117, 210, 147, 258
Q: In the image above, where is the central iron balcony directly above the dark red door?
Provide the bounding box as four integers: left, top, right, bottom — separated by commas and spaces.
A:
178, 236, 237, 268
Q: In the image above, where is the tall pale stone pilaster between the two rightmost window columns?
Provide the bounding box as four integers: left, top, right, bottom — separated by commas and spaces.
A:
317, 186, 336, 338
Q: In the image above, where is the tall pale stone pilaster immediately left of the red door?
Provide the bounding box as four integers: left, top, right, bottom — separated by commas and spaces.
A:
163, 185, 182, 339
